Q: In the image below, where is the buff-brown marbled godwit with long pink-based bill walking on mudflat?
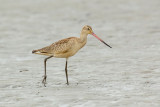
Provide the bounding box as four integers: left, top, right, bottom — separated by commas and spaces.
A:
32, 25, 112, 86
